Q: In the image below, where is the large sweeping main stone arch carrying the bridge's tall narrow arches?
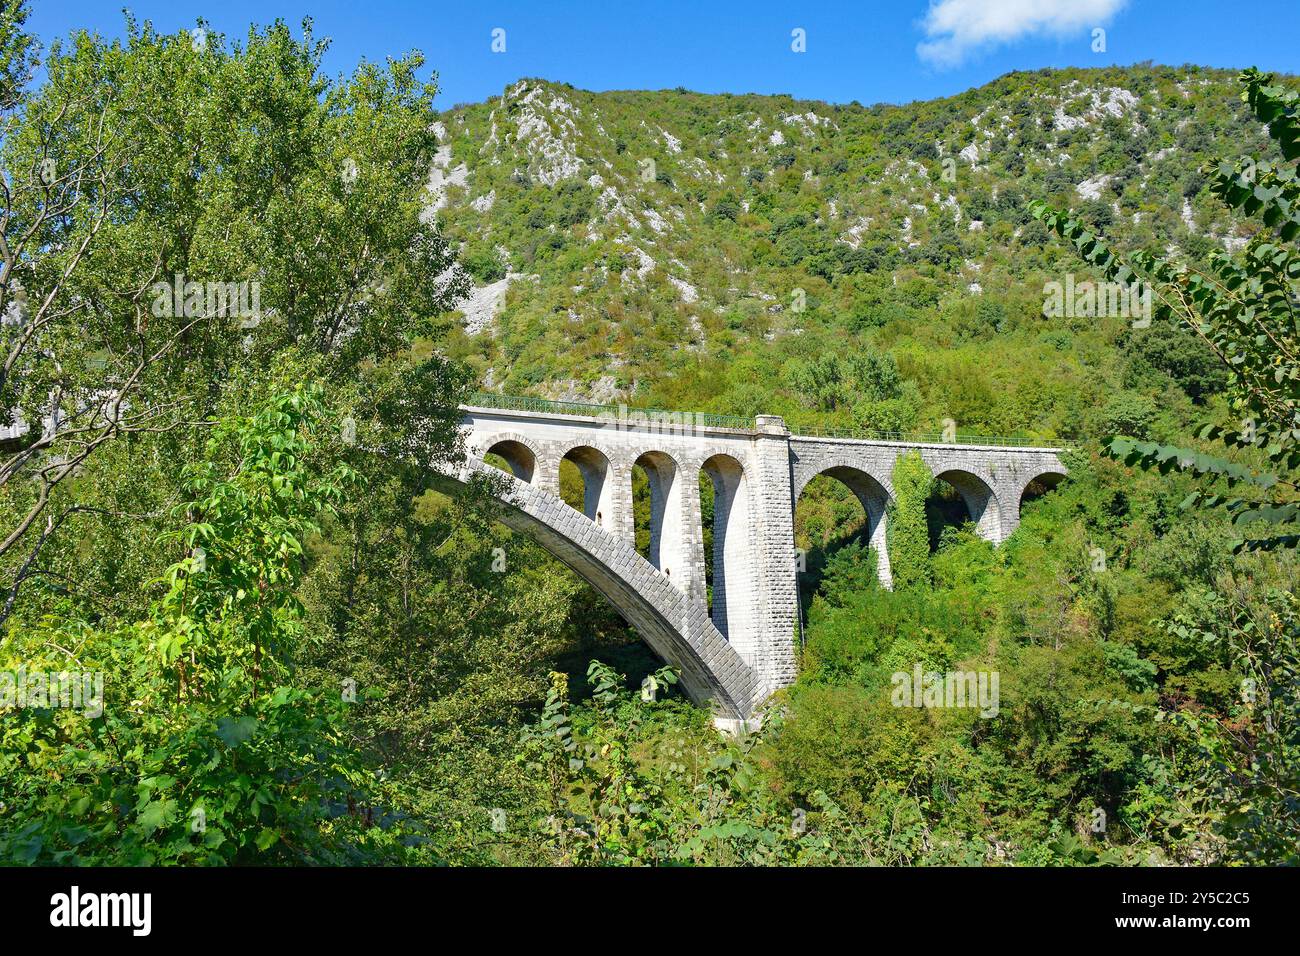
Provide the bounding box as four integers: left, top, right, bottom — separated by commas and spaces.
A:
437, 458, 762, 721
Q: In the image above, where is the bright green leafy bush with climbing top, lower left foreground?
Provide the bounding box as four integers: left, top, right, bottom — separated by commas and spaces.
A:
0, 385, 382, 865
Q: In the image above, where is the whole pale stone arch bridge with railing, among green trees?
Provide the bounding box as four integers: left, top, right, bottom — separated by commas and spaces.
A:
450, 395, 1065, 726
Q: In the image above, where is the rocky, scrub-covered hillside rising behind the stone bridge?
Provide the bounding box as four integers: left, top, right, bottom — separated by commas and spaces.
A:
430, 66, 1269, 437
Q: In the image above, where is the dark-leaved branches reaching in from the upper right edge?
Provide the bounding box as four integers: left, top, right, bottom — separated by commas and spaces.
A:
1031, 70, 1300, 550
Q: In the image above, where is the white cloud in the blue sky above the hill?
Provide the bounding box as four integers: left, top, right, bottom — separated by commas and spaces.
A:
917, 0, 1127, 66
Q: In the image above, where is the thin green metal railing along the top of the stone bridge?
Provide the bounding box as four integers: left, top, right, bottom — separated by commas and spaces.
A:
467, 392, 1050, 447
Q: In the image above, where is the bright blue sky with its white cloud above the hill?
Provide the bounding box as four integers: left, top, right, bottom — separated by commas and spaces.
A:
22, 0, 1300, 108
